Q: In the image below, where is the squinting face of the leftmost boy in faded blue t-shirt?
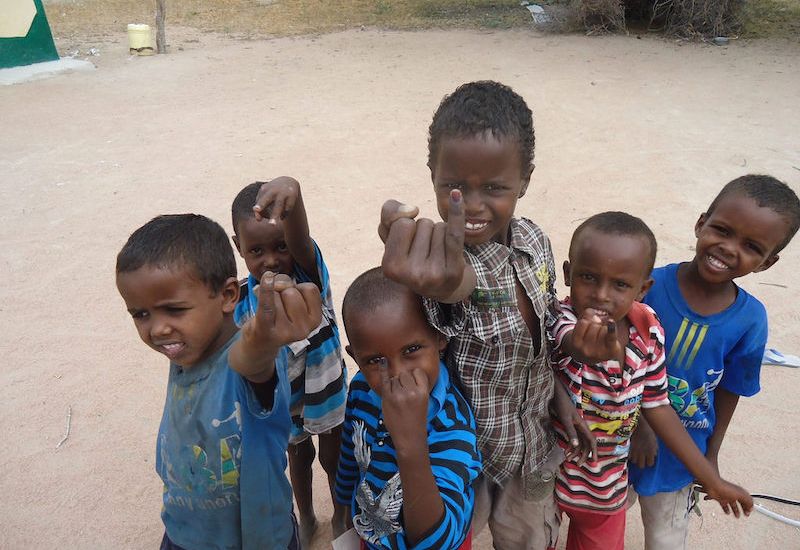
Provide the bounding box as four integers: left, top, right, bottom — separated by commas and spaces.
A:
117, 265, 239, 368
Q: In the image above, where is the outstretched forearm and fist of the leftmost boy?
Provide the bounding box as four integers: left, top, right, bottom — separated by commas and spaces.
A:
228, 272, 322, 383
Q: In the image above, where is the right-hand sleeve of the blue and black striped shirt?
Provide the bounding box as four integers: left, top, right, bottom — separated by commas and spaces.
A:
381, 393, 481, 550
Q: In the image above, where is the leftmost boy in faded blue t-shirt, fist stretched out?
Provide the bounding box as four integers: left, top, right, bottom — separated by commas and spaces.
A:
116, 214, 321, 550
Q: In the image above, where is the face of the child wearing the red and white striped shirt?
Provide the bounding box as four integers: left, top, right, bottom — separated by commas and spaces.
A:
564, 228, 653, 321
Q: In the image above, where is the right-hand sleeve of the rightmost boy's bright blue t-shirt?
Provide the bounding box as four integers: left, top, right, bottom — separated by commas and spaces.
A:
720, 302, 768, 397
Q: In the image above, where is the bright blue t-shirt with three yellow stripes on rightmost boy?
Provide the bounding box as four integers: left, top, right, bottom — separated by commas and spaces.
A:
629, 264, 767, 496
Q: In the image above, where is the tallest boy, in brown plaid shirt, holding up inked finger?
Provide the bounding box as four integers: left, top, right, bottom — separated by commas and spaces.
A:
378, 82, 591, 550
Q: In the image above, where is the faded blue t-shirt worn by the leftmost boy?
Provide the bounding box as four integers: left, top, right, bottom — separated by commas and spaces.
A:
156, 332, 294, 550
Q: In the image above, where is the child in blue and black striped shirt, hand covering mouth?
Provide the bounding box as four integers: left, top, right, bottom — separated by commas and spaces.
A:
336, 268, 481, 550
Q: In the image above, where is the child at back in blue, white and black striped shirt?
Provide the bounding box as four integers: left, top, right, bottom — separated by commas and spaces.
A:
231, 177, 347, 547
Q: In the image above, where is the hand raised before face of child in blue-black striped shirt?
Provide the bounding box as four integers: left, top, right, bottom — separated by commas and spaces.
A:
378, 359, 431, 452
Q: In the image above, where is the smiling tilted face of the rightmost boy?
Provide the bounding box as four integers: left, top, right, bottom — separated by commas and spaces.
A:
692, 193, 789, 283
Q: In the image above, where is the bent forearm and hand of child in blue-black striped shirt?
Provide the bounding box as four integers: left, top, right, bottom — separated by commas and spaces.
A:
380, 360, 444, 546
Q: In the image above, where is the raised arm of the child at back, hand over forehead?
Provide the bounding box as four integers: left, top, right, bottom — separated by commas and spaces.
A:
253, 176, 321, 287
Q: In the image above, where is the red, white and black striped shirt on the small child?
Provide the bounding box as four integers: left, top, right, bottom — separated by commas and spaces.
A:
550, 298, 669, 513
